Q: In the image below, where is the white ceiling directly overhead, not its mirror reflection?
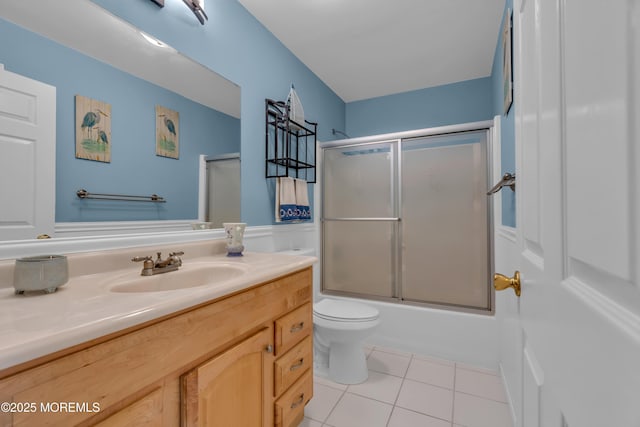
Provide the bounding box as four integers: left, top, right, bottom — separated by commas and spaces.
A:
238, 0, 505, 102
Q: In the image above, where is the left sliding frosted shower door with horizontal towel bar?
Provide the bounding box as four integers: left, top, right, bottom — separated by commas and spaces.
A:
322, 142, 398, 298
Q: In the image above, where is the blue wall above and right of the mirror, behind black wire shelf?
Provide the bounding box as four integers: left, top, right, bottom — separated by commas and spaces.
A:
94, 0, 345, 226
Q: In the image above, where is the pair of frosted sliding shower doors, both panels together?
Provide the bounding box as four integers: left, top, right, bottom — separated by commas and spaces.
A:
322, 130, 491, 310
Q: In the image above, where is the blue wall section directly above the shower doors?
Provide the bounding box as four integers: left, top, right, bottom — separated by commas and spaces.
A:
346, 77, 493, 138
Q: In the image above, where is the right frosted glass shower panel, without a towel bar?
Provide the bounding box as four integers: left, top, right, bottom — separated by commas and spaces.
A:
401, 134, 490, 309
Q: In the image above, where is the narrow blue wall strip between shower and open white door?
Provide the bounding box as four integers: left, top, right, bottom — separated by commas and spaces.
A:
491, 0, 517, 227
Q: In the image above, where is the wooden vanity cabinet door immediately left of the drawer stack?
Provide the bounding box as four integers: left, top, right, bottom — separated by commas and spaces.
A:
182, 327, 273, 427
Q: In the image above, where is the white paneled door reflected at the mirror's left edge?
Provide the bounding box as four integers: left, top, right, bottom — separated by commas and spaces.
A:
0, 64, 56, 240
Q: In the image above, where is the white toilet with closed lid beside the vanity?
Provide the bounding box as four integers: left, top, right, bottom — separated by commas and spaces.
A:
313, 298, 380, 384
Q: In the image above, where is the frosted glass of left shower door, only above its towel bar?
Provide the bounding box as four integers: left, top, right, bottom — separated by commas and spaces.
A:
323, 143, 396, 218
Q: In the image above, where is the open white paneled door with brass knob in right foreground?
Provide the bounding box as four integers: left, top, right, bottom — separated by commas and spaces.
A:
502, 0, 640, 427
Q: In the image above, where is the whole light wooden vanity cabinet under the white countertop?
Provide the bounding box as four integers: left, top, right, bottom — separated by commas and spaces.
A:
0, 267, 313, 427
